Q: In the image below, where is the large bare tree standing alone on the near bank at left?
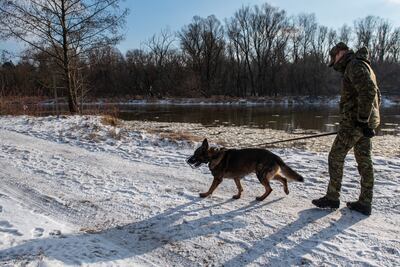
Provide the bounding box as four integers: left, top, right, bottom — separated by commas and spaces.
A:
0, 0, 128, 113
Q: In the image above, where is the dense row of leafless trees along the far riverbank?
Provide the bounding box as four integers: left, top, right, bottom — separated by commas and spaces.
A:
0, 4, 400, 100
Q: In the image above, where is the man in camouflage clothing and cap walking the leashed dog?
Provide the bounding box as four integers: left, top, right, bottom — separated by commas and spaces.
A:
312, 42, 381, 215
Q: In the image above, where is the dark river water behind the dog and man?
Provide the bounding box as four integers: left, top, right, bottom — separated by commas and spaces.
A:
114, 105, 400, 135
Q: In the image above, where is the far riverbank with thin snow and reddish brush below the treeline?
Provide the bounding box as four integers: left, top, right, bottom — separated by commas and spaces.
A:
0, 96, 400, 116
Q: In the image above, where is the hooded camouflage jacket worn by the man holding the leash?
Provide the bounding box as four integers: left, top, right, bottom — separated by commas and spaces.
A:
334, 47, 381, 129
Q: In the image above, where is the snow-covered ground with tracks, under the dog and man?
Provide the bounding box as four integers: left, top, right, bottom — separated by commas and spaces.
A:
0, 116, 400, 266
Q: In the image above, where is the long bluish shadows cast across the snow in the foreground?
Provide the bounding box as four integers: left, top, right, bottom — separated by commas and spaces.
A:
0, 196, 364, 266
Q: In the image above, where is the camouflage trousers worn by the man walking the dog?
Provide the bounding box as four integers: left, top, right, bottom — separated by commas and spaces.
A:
327, 127, 374, 204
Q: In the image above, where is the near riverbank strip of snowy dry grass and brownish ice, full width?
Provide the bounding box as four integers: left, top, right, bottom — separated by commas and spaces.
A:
0, 116, 400, 157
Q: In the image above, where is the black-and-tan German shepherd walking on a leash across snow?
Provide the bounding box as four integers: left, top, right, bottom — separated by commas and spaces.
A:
187, 139, 304, 201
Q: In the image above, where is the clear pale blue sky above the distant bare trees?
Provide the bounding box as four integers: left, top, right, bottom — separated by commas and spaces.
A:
0, 0, 400, 56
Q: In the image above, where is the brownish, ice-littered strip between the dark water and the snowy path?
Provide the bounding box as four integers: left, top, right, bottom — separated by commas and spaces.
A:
123, 121, 400, 157
